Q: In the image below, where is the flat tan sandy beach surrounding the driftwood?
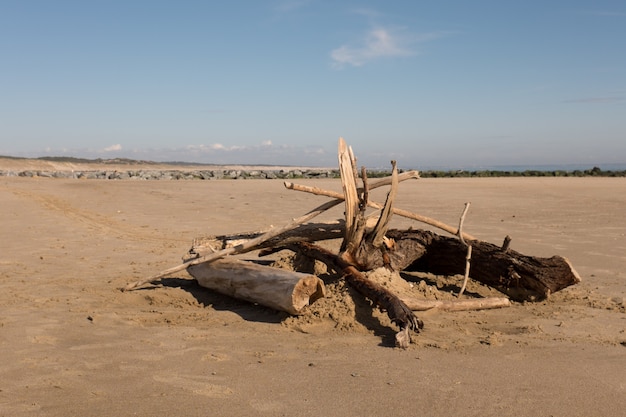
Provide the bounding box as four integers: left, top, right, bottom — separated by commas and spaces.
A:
0, 164, 626, 417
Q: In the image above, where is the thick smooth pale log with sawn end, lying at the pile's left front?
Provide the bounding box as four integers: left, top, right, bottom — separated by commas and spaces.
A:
187, 258, 325, 315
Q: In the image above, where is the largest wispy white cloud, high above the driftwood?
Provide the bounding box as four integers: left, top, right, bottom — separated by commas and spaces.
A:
330, 26, 443, 69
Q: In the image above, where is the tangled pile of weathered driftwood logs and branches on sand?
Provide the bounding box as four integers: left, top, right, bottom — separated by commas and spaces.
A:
125, 138, 580, 347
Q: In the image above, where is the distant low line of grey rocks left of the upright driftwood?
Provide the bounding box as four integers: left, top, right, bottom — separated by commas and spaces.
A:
0, 168, 340, 180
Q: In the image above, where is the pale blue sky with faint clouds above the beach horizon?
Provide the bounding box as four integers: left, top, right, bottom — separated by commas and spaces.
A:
0, 0, 626, 168
